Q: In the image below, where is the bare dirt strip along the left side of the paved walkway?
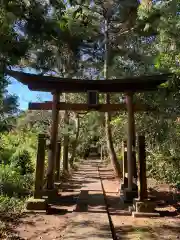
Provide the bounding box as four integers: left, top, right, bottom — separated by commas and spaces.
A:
13, 162, 85, 240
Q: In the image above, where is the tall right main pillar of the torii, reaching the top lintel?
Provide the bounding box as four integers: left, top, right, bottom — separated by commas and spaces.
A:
126, 93, 134, 191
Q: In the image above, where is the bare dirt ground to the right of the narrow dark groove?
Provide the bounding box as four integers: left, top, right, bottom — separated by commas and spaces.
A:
100, 164, 180, 240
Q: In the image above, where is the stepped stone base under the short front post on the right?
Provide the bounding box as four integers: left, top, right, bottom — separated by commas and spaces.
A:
132, 199, 160, 217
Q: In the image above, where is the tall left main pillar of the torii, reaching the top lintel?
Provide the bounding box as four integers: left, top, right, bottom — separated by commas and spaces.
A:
47, 93, 60, 189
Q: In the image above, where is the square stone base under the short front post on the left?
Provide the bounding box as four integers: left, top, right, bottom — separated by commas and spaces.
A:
26, 198, 48, 211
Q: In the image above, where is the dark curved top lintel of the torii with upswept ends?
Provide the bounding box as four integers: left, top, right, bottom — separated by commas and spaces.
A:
6, 70, 170, 93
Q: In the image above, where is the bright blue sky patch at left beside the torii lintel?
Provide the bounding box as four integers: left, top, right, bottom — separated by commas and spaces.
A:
8, 69, 52, 110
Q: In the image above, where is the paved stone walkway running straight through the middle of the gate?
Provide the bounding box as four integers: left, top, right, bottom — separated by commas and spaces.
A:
59, 160, 112, 240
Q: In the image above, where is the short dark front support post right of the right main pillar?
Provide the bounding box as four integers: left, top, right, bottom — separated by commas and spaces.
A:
138, 136, 147, 201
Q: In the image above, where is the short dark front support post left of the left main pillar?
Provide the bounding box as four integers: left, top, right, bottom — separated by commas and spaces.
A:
34, 134, 46, 199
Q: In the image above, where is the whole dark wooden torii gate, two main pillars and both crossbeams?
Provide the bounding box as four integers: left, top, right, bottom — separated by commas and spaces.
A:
6, 70, 169, 206
